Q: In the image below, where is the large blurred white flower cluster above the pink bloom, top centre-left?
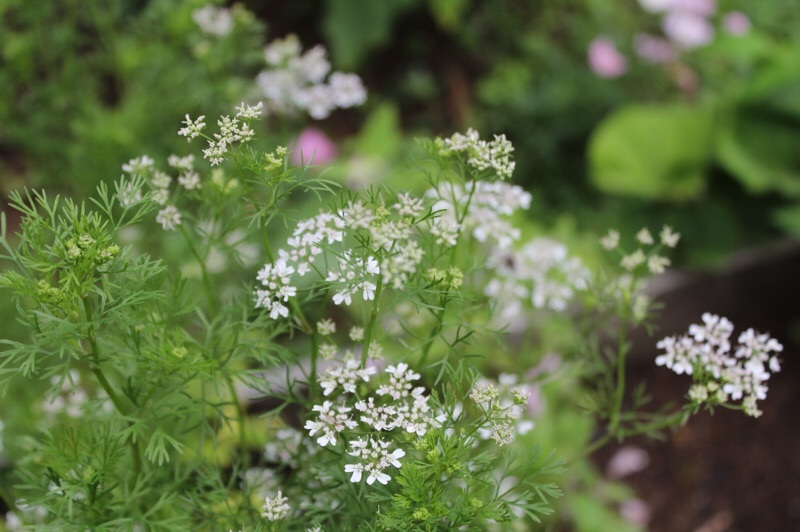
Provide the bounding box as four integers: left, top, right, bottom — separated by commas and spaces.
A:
256, 35, 367, 120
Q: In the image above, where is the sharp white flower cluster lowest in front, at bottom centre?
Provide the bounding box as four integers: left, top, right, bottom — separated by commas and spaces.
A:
305, 360, 438, 484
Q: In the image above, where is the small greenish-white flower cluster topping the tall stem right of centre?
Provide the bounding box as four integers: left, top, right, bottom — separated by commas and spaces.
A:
436, 128, 517, 179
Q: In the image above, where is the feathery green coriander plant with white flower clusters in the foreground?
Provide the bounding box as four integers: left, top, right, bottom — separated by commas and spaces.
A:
0, 98, 780, 530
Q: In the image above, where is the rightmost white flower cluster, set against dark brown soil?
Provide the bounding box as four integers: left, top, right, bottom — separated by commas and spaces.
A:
656, 312, 783, 417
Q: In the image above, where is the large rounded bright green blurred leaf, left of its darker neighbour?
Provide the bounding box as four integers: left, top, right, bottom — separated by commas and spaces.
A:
589, 104, 712, 200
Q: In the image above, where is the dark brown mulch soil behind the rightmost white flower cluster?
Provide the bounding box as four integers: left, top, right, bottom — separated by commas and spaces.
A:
595, 242, 800, 532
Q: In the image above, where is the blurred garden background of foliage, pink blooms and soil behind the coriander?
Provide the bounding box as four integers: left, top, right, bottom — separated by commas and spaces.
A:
0, 0, 800, 532
